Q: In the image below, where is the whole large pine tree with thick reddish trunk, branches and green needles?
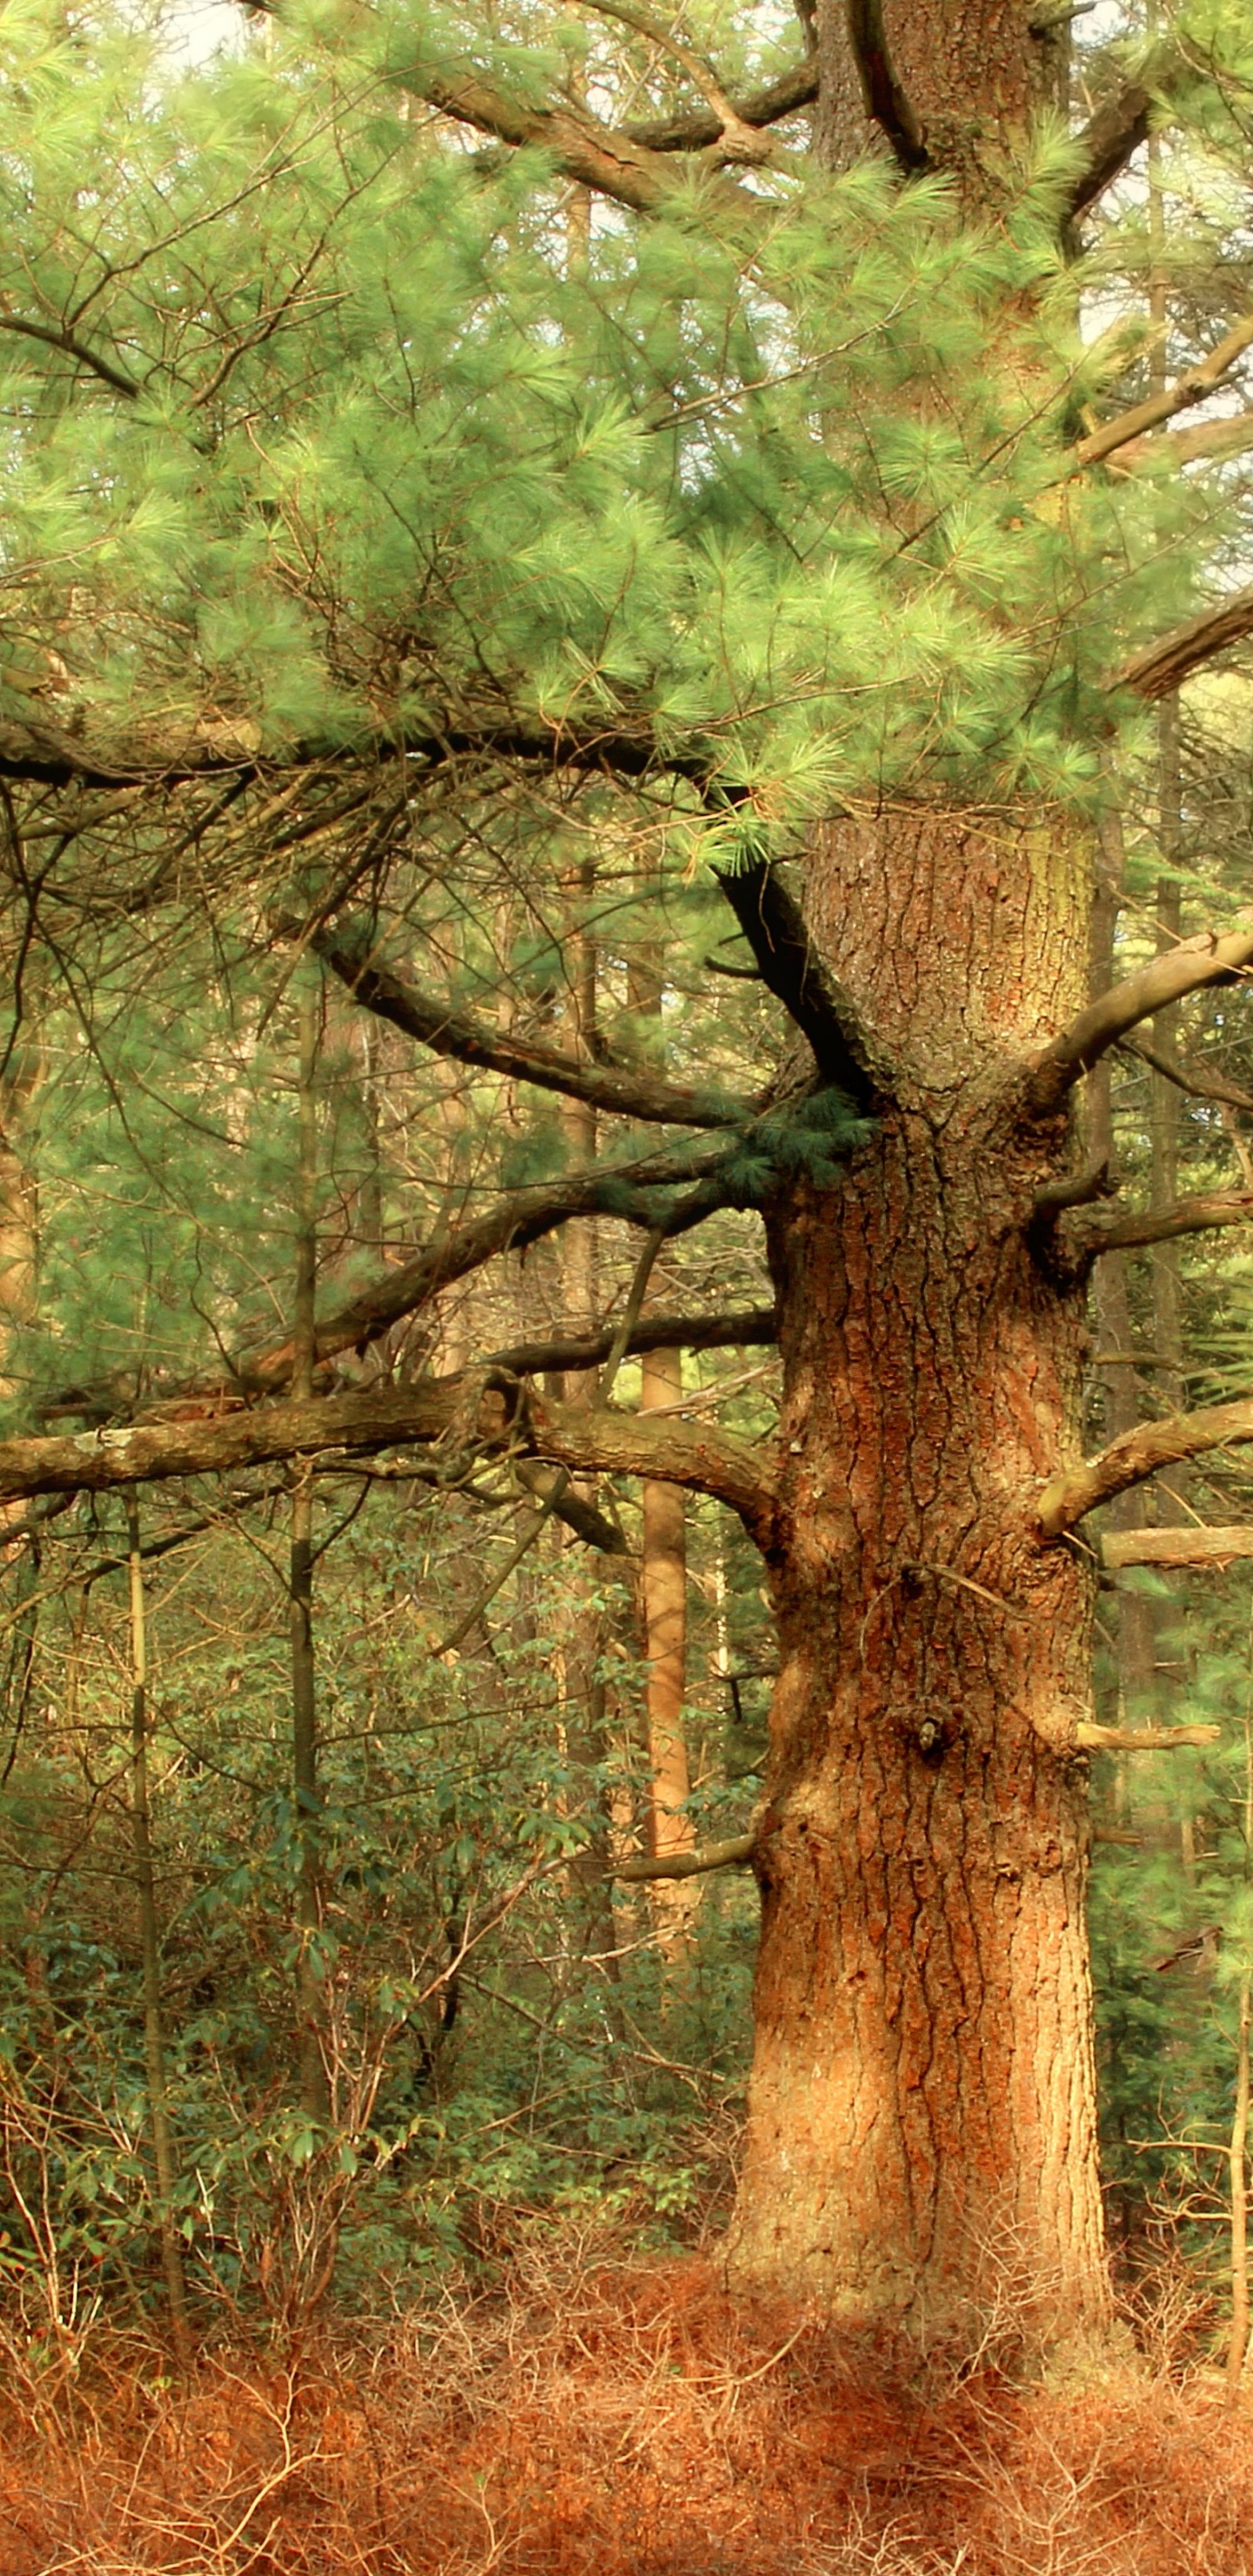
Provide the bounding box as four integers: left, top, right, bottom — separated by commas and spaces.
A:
0, 0, 1253, 2331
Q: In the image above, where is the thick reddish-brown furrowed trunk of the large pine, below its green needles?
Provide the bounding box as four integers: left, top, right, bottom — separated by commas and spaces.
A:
732, 811, 1106, 2337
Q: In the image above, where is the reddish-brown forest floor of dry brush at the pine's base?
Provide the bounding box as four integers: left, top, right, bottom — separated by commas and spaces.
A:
0, 2233, 1253, 2576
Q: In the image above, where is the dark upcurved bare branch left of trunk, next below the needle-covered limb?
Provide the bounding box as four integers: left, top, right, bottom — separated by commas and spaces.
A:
310, 925, 747, 1128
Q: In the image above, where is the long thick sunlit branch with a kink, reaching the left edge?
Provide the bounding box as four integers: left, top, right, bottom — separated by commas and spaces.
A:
0, 1371, 774, 1540
